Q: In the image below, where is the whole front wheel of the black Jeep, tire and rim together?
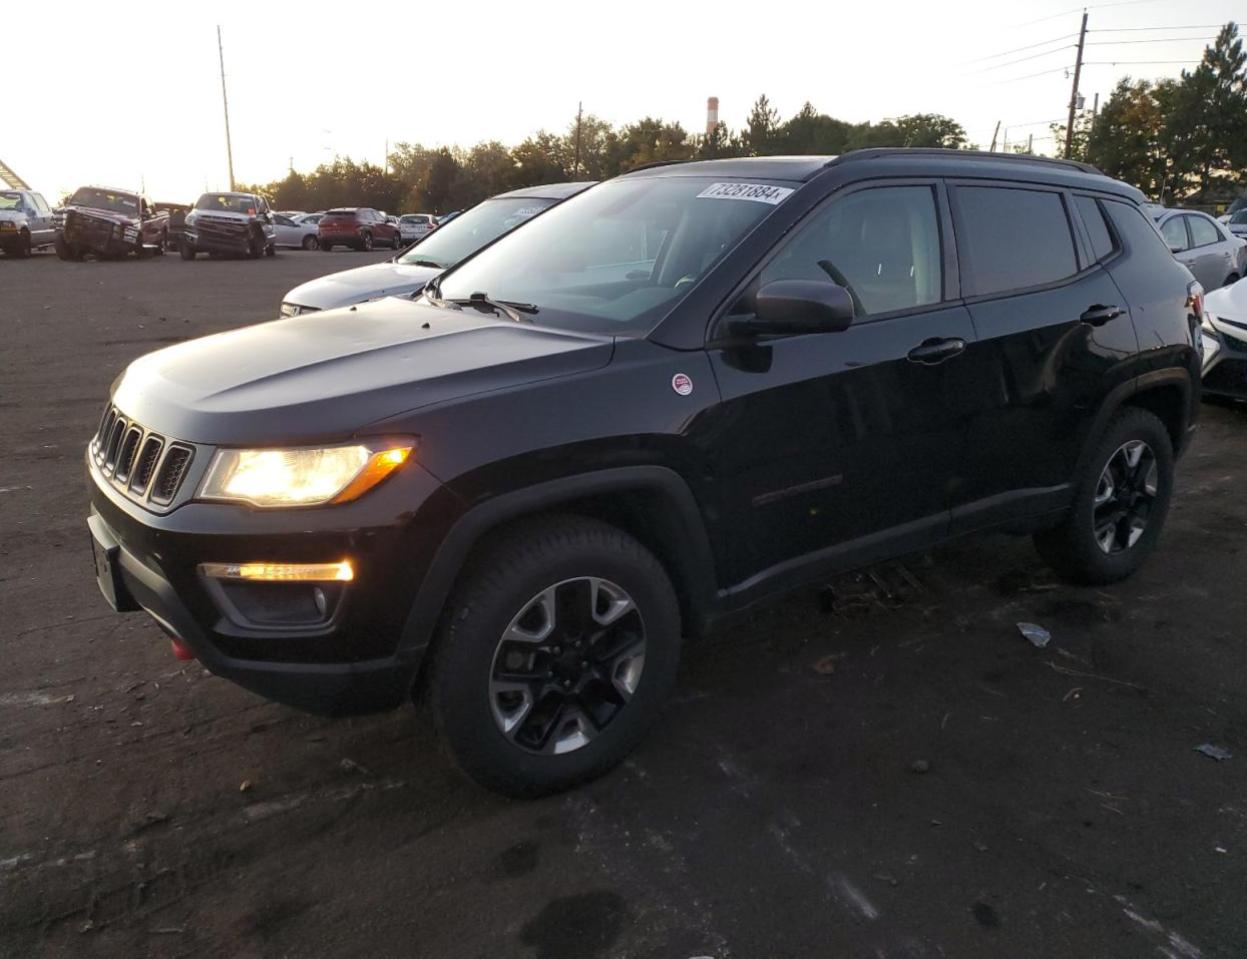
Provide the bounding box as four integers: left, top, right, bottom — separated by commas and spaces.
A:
428, 516, 681, 797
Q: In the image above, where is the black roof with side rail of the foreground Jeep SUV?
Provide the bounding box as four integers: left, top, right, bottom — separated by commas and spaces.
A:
625, 147, 1145, 202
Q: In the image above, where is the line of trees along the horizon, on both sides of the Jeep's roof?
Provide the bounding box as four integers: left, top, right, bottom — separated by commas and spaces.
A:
239, 22, 1247, 213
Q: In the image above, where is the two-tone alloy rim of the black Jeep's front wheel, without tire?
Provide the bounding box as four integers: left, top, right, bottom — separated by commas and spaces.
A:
489, 576, 646, 754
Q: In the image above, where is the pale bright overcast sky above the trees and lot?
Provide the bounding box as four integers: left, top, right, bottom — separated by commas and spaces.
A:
7, 0, 1245, 202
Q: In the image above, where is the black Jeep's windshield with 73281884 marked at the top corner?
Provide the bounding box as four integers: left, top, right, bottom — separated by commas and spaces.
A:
433, 176, 794, 333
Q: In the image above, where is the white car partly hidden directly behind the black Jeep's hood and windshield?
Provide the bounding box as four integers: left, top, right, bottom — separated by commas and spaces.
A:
281, 182, 592, 317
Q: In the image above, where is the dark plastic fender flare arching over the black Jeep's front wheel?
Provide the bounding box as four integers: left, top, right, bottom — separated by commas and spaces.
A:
397, 465, 716, 665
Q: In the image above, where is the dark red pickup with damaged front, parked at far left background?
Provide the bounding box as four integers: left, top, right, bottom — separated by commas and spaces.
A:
54, 187, 168, 259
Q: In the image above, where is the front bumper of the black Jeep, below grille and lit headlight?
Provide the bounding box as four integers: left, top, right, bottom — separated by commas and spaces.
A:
87, 446, 453, 716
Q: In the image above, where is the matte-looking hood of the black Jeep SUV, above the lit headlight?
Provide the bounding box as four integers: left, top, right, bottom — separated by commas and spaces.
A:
112, 299, 612, 445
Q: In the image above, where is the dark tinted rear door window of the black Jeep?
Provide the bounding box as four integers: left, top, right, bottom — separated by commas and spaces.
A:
955, 187, 1079, 296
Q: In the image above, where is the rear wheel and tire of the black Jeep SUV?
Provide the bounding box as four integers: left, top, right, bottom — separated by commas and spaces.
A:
1035, 407, 1173, 585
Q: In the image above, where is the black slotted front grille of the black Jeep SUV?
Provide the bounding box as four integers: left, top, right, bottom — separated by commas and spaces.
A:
90, 404, 195, 506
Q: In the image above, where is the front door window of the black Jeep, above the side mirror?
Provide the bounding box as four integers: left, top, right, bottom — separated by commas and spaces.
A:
758, 186, 943, 316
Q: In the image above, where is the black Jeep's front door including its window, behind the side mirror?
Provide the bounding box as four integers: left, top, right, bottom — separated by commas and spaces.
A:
710, 181, 974, 594
